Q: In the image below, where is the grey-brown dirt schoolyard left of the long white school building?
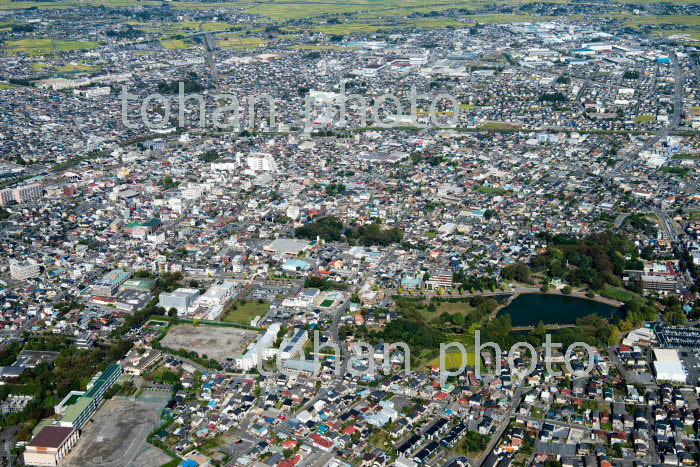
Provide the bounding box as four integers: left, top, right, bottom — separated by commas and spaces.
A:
160, 324, 258, 363
